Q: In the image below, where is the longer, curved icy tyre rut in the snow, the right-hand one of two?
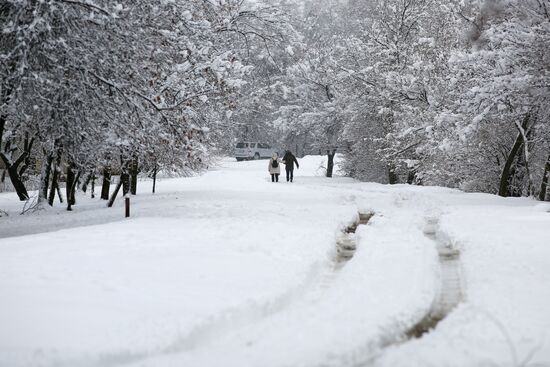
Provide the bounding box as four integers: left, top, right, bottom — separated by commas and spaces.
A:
407, 218, 463, 338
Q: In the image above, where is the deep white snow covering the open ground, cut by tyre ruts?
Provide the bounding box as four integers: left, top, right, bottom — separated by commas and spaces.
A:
0, 157, 550, 367
